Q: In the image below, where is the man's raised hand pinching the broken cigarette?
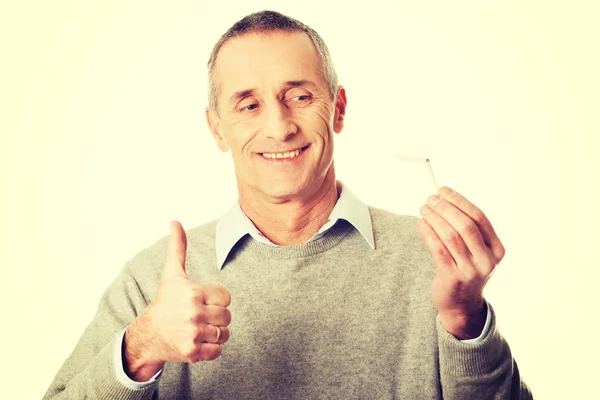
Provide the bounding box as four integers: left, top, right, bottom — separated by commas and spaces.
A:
417, 186, 505, 340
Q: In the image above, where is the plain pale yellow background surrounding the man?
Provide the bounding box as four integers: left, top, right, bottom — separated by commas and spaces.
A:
0, 0, 600, 399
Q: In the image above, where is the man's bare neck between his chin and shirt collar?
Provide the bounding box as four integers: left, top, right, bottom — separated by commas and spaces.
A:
239, 165, 340, 246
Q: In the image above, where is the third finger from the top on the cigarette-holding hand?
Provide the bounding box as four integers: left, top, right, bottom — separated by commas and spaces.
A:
420, 204, 471, 269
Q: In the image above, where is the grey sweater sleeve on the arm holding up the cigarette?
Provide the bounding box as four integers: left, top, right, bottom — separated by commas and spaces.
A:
436, 302, 533, 400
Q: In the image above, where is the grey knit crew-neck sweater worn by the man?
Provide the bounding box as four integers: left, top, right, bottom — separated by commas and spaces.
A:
44, 207, 532, 400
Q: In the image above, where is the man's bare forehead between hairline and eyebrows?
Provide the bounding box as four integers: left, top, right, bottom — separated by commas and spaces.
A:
215, 31, 326, 98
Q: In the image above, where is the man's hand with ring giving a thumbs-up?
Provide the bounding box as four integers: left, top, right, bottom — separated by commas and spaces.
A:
123, 221, 231, 382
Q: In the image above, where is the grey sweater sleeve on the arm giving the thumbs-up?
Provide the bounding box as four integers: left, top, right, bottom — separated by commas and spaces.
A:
44, 263, 158, 400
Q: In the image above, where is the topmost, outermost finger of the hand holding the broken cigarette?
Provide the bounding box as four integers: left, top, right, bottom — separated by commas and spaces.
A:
438, 186, 506, 262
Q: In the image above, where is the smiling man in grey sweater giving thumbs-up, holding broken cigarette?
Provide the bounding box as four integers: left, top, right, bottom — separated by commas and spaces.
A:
46, 11, 531, 399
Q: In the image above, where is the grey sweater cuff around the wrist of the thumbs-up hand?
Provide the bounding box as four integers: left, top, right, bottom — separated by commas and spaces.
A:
88, 330, 158, 400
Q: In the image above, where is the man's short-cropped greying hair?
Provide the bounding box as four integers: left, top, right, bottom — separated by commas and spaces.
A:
208, 10, 337, 115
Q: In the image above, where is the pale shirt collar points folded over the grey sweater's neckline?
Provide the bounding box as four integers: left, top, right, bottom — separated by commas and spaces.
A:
215, 180, 375, 269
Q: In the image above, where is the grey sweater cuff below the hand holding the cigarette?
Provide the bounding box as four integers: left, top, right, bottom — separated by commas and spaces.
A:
436, 302, 507, 376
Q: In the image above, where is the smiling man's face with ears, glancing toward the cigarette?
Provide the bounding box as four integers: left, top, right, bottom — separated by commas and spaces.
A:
207, 32, 346, 201
